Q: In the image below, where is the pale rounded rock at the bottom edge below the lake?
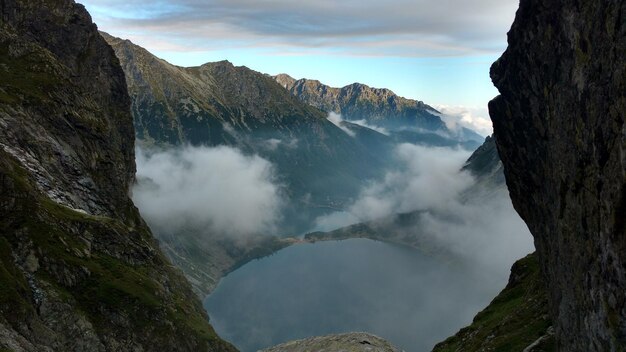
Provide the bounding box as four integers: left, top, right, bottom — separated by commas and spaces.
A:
262, 332, 400, 352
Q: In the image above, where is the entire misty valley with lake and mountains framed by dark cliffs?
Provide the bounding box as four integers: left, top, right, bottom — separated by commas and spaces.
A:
98, 33, 533, 351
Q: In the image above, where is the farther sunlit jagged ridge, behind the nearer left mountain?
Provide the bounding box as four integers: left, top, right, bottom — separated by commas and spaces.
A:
274, 74, 484, 150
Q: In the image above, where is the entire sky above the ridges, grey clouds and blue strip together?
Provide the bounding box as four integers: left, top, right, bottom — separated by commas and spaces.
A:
79, 0, 518, 130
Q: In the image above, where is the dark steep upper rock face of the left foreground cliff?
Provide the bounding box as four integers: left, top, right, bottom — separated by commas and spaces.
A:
0, 0, 135, 215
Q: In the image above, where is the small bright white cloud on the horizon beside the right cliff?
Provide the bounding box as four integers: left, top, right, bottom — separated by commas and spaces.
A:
436, 105, 493, 137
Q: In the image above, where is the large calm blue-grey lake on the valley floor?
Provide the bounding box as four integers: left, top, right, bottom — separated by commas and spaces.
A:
204, 239, 505, 352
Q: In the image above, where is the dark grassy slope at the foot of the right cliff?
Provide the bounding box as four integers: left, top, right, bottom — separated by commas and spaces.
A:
433, 254, 555, 352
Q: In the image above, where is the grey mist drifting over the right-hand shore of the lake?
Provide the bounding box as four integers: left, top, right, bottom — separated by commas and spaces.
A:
316, 144, 533, 272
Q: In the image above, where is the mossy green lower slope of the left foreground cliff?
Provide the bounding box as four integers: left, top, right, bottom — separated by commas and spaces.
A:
0, 152, 233, 350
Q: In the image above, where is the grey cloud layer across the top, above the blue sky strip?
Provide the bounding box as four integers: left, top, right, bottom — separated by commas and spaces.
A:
84, 0, 518, 56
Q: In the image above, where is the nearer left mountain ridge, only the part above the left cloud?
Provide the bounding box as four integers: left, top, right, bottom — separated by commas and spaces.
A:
104, 34, 389, 223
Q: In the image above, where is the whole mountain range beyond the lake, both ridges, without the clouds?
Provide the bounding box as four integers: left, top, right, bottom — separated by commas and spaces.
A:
102, 33, 490, 294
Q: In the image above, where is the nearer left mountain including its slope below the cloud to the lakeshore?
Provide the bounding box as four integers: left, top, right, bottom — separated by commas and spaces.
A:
103, 33, 400, 295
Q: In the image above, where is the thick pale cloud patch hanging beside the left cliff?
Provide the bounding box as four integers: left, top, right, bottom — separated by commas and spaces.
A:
133, 147, 284, 237
